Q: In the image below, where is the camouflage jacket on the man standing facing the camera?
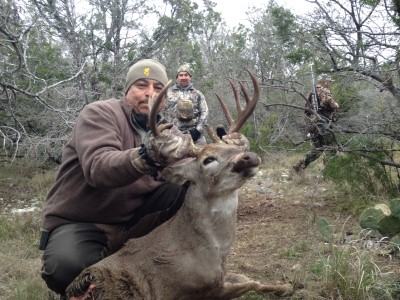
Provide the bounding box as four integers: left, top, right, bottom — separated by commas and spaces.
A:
161, 84, 208, 132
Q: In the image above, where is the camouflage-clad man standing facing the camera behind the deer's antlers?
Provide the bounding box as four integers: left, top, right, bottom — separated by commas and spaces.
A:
162, 65, 208, 146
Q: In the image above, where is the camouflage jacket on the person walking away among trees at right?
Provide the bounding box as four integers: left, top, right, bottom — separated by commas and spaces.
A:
305, 85, 339, 121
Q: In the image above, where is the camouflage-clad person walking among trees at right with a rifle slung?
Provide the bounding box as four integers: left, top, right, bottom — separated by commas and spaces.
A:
293, 78, 339, 173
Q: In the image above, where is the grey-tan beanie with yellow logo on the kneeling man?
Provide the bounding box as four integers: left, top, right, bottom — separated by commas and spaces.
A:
125, 59, 168, 94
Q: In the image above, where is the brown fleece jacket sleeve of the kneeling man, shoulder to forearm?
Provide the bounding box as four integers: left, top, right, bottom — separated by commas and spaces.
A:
71, 105, 148, 188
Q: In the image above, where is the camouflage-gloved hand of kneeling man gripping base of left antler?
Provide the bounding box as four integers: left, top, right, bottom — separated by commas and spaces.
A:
145, 124, 193, 167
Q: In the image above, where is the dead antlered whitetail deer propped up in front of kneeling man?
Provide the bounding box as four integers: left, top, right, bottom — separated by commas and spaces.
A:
67, 71, 293, 300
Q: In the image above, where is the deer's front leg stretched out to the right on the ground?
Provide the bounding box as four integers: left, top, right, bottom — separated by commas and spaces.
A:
218, 273, 293, 299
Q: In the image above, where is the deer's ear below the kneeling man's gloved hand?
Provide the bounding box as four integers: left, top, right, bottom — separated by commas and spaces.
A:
161, 157, 196, 185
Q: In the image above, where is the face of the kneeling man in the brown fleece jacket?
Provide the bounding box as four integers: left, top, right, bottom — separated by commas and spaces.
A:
125, 79, 165, 115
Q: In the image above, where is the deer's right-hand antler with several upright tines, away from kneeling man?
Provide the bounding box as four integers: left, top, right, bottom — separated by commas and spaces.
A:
207, 70, 260, 142
